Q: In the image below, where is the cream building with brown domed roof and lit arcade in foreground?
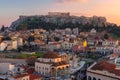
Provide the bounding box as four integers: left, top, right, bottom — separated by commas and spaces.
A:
35, 52, 69, 76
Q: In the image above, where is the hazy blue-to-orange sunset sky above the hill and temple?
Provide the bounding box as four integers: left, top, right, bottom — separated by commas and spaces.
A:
0, 0, 120, 26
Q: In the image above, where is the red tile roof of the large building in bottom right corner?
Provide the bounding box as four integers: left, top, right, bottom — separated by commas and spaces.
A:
91, 61, 120, 76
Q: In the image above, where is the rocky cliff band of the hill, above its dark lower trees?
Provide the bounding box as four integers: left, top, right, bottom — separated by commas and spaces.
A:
10, 15, 113, 30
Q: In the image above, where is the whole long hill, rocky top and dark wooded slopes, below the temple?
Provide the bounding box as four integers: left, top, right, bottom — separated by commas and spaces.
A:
11, 16, 120, 37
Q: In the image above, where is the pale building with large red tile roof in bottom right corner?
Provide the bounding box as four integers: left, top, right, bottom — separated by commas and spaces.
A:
87, 61, 120, 80
